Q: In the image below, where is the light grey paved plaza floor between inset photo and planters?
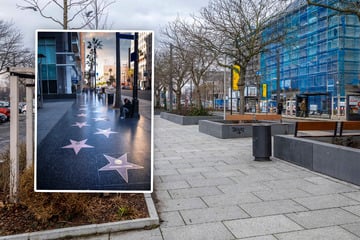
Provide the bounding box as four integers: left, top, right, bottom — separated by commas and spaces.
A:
74, 116, 360, 240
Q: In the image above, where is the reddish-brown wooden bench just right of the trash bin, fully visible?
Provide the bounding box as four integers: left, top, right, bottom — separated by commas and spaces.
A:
294, 121, 337, 137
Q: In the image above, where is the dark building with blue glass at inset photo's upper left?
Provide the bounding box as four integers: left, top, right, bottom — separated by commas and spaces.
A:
37, 32, 82, 98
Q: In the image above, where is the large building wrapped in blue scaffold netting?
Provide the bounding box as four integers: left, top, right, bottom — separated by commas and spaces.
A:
260, 1, 360, 116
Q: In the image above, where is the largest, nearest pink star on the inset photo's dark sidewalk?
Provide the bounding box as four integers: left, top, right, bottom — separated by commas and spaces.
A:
99, 153, 144, 183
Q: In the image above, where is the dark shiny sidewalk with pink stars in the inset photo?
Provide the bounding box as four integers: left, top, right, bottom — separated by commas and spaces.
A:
36, 94, 151, 191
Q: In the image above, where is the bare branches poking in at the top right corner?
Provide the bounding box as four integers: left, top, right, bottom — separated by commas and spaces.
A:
306, 0, 360, 21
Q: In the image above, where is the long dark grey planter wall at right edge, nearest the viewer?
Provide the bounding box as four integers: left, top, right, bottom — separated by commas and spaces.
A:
274, 136, 360, 185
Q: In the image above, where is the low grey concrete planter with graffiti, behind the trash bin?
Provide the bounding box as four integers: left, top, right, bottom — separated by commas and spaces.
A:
199, 120, 295, 139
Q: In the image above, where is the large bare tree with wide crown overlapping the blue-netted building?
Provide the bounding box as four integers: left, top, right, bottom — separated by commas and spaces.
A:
193, 0, 287, 114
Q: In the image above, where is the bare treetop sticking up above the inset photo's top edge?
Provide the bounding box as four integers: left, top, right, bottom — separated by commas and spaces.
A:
17, 0, 113, 29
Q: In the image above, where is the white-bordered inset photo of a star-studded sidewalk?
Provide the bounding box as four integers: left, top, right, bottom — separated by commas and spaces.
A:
34, 30, 154, 192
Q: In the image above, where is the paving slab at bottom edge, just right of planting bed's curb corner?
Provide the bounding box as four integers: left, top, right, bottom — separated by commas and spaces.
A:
161, 223, 234, 240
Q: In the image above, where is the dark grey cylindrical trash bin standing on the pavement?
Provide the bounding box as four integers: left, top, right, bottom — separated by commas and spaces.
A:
252, 124, 271, 161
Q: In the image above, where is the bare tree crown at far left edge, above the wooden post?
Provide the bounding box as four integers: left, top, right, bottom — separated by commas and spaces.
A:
0, 20, 34, 74
